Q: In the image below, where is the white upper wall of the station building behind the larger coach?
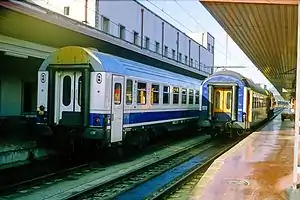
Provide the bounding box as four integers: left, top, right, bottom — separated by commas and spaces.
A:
33, 0, 214, 75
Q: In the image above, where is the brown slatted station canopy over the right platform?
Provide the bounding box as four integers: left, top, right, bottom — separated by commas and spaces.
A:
200, 0, 298, 99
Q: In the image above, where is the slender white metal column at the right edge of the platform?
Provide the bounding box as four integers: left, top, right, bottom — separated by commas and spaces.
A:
293, 0, 300, 189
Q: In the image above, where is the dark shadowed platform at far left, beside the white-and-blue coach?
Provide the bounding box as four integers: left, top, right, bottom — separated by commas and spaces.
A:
0, 116, 53, 170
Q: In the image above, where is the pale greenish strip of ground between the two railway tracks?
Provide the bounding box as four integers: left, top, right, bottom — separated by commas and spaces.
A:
0, 135, 209, 200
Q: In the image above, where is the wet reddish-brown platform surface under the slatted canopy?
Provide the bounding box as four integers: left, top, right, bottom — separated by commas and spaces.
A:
190, 115, 299, 200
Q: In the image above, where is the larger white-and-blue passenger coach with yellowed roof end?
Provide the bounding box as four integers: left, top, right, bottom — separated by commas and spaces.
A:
37, 46, 202, 145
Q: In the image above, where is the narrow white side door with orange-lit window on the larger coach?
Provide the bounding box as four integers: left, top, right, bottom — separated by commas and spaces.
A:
110, 75, 124, 142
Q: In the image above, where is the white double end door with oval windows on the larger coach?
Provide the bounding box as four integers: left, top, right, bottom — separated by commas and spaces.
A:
54, 71, 82, 124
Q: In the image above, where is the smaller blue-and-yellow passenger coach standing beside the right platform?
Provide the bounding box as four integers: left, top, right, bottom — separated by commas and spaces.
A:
198, 70, 274, 136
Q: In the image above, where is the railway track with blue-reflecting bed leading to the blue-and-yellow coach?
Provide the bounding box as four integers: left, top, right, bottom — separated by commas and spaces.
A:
77, 138, 236, 200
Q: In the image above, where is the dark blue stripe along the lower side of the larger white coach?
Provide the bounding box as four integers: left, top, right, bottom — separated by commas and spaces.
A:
90, 110, 200, 126
